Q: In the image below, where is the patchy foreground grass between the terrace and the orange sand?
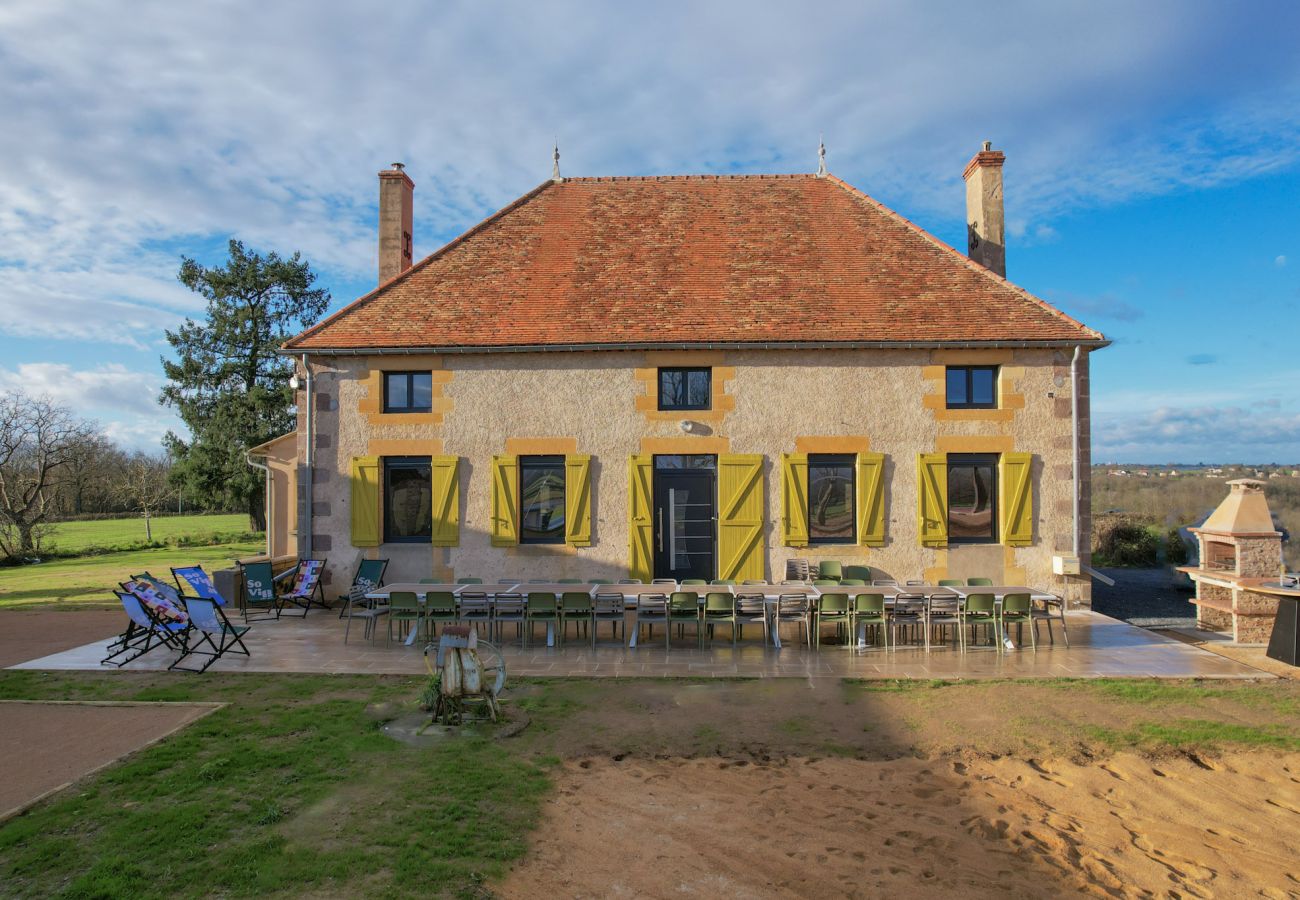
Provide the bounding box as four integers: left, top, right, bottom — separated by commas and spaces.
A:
0, 671, 1300, 897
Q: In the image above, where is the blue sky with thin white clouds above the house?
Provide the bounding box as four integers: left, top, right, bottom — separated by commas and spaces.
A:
0, 0, 1300, 462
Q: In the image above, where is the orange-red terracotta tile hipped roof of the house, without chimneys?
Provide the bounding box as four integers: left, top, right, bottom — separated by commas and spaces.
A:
285, 176, 1104, 350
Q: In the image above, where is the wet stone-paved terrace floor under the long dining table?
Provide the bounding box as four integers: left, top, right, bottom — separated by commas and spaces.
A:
13, 610, 1273, 679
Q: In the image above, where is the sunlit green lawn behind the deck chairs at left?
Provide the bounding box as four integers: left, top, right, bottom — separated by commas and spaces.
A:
0, 541, 265, 607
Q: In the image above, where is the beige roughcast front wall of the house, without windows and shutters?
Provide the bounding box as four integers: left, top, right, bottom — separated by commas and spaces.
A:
289, 349, 1091, 606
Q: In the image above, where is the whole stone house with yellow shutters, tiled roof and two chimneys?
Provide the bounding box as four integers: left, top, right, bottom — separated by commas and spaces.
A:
270, 144, 1108, 605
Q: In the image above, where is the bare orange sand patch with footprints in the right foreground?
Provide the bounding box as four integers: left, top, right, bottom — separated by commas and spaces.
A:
501, 753, 1300, 897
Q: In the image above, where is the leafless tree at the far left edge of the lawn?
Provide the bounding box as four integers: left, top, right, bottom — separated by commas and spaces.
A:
0, 391, 95, 557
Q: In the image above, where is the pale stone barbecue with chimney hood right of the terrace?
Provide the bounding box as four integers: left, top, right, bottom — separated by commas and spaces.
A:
1180, 479, 1282, 644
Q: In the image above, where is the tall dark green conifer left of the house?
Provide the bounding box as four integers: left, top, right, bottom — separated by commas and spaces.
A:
159, 241, 330, 531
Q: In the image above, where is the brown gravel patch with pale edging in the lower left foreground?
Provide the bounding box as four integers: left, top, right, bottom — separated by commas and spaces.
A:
0, 701, 216, 819
